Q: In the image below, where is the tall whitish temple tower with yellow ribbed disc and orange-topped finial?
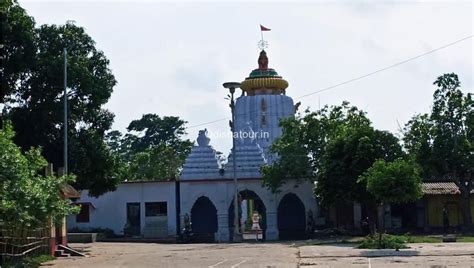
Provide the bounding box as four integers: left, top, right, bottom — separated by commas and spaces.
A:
235, 50, 295, 161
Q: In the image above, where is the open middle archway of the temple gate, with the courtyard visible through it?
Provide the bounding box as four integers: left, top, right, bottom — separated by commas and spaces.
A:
228, 190, 267, 240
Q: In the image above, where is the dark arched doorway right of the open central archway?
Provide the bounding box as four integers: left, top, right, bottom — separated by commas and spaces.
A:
278, 193, 306, 240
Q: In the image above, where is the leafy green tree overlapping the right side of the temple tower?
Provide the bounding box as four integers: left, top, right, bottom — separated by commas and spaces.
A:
262, 102, 370, 191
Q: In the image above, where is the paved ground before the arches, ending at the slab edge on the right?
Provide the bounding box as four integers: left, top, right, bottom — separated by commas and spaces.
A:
42, 243, 298, 268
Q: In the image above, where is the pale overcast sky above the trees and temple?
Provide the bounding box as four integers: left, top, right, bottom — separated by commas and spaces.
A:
20, 0, 474, 152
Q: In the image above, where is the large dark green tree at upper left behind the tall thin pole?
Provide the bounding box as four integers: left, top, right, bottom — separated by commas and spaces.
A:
2, 0, 118, 196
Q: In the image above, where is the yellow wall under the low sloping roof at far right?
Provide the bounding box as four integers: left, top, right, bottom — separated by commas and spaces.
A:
426, 195, 474, 227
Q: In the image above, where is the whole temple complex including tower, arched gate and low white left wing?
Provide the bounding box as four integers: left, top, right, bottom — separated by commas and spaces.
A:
69, 50, 319, 242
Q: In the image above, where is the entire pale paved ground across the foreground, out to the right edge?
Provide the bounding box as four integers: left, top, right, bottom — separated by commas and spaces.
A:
45, 242, 474, 268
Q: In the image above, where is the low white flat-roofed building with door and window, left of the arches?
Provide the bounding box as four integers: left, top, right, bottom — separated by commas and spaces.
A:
67, 181, 177, 238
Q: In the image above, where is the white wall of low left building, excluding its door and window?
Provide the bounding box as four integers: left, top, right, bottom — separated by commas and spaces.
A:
67, 182, 176, 236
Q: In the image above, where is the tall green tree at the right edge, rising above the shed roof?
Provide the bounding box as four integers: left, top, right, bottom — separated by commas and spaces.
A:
404, 73, 474, 227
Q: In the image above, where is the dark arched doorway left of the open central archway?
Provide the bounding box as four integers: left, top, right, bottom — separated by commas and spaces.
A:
191, 196, 217, 242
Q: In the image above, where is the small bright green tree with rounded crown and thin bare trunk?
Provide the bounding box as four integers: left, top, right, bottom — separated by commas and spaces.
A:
358, 158, 423, 247
